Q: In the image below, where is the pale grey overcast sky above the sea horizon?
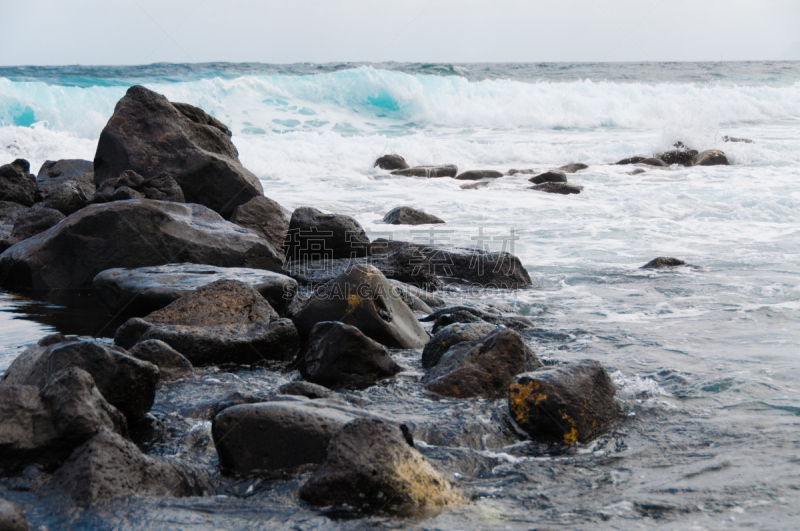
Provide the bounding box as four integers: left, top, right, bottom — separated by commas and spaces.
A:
0, 0, 800, 65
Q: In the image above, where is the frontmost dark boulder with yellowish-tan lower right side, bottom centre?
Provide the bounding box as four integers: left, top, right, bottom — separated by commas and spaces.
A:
300, 419, 466, 515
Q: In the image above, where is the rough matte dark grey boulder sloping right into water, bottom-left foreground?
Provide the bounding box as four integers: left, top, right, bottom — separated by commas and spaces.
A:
52, 431, 213, 507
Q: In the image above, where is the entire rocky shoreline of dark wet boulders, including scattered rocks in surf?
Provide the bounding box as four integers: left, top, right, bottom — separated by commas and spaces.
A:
0, 86, 712, 529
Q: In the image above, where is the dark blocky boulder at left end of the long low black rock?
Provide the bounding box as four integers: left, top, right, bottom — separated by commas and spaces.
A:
284, 207, 370, 261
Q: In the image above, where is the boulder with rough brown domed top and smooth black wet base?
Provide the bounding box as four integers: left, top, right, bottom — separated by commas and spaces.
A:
114, 280, 297, 365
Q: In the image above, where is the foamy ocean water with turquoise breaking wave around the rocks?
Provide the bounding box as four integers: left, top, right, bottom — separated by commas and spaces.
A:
0, 62, 800, 529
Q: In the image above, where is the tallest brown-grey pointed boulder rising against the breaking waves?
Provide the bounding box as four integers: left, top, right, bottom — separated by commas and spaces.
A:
94, 85, 263, 218
